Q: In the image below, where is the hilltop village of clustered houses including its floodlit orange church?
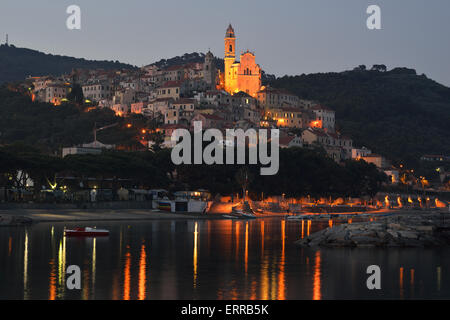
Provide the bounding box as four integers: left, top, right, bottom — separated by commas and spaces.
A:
26, 25, 398, 182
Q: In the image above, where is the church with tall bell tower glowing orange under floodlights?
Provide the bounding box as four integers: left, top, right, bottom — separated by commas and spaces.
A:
223, 24, 261, 97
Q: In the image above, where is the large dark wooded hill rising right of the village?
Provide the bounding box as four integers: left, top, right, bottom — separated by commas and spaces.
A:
271, 66, 450, 165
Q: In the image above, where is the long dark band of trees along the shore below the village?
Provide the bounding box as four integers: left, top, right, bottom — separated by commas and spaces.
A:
0, 145, 386, 198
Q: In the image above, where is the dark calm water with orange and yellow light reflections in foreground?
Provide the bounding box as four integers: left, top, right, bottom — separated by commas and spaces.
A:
0, 218, 450, 299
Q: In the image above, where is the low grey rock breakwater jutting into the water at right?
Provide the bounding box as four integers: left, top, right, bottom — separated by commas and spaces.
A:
296, 213, 450, 247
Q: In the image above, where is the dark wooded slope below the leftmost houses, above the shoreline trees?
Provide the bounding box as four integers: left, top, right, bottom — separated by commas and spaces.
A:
0, 87, 143, 152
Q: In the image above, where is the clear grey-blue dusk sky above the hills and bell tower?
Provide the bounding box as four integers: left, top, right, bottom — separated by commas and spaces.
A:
0, 0, 450, 86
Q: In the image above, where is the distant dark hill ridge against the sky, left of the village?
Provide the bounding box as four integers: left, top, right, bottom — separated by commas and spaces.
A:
0, 45, 134, 84
